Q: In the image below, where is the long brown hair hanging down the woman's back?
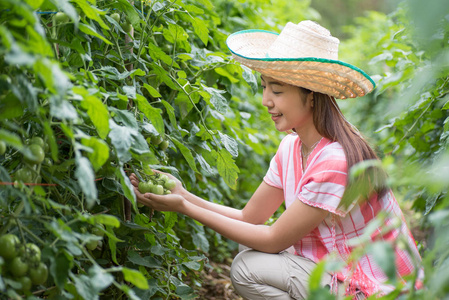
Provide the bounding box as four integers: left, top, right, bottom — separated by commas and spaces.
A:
304, 89, 387, 202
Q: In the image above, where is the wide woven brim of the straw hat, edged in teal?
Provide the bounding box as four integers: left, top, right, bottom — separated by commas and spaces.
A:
226, 30, 375, 99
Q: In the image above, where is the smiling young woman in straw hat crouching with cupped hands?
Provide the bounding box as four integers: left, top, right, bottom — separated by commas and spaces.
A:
130, 21, 420, 299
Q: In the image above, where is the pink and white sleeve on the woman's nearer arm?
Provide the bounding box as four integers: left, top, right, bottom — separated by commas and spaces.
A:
298, 143, 355, 217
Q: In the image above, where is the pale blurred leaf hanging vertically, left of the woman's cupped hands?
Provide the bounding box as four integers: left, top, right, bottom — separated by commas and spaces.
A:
75, 151, 98, 208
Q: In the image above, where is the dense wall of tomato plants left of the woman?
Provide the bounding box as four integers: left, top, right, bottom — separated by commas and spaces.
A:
0, 0, 278, 299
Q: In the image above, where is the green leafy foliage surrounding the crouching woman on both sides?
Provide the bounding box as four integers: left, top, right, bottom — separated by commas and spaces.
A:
0, 0, 449, 299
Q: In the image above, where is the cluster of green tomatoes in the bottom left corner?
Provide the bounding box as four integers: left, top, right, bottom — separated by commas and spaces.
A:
0, 233, 48, 292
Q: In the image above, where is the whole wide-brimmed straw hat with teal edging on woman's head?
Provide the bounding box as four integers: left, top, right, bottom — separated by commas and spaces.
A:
226, 21, 375, 99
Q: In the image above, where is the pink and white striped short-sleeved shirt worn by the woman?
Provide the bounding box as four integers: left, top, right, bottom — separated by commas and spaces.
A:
264, 133, 421, 296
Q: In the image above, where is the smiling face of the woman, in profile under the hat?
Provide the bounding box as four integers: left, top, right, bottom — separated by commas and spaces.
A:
261, 76, 314, 133
